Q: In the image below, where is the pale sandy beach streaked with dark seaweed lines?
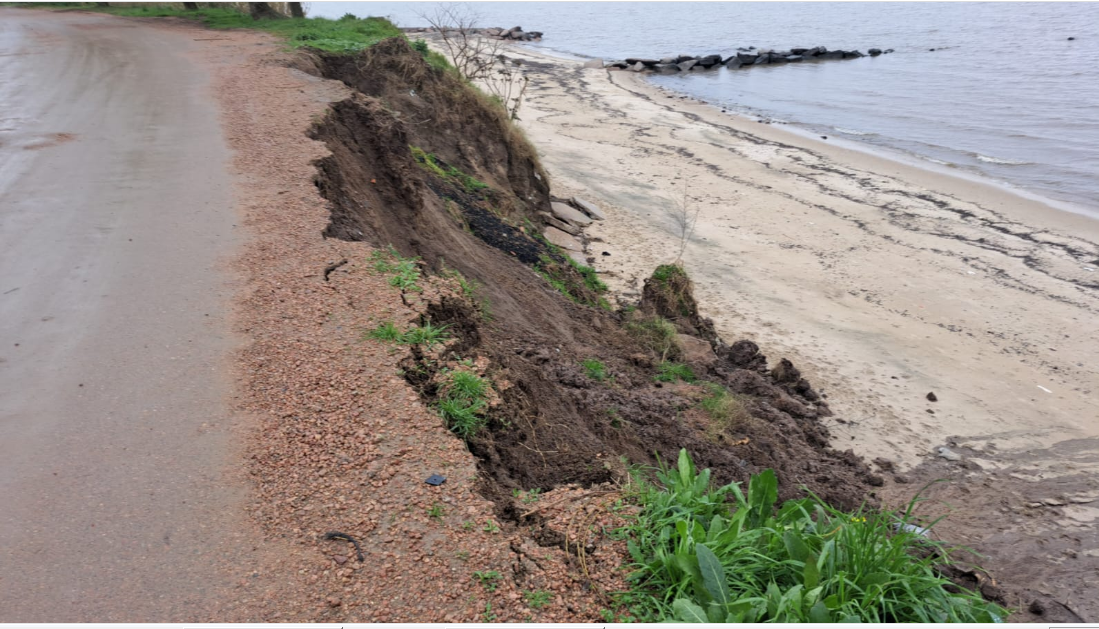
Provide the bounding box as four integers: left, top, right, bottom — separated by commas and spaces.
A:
513, 51, 1099, 615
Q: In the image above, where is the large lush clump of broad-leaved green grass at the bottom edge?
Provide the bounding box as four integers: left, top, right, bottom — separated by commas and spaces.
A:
622, 450, 1007, 624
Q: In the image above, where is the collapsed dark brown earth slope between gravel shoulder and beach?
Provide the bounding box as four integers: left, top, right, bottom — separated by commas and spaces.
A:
298, 40, 880, 519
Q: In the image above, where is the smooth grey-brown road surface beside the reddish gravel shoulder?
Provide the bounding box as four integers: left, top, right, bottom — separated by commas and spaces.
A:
0, 8, 245, 622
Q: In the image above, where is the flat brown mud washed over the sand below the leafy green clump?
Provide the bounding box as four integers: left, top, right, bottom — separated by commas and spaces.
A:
882, 435, 1099, 624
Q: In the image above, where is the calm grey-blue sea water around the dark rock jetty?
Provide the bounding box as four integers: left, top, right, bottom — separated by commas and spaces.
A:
310, 2, 1099, 213
